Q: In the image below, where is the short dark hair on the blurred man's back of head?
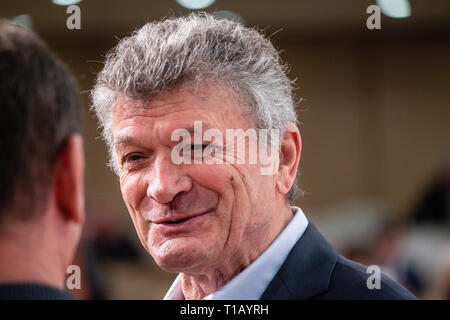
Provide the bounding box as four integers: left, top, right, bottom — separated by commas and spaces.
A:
0, 20, 81, 231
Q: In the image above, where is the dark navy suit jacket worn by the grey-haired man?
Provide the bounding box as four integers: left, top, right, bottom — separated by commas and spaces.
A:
261, 222, 416, 300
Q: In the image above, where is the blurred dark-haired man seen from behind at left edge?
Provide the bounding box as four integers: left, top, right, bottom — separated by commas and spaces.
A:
0, 21, 84, 299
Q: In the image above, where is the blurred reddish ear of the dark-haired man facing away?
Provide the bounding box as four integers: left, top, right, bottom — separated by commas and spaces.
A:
53, 134, 85, 224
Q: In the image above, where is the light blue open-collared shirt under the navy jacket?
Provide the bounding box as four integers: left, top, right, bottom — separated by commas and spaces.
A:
164, 206, 308, 300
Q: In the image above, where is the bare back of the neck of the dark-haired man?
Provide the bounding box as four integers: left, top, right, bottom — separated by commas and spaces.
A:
0, 221, 65, 289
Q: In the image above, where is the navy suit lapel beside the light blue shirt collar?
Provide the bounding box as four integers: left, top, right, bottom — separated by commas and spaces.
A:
261, 222, 338, 300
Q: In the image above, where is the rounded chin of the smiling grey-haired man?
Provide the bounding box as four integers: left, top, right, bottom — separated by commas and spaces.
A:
149, 237, 207, 273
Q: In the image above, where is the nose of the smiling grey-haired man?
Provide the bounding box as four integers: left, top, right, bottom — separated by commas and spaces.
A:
147, 152, 192, 203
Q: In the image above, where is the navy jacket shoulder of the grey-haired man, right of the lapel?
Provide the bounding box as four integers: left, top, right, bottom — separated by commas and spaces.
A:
313, 255, 416, 300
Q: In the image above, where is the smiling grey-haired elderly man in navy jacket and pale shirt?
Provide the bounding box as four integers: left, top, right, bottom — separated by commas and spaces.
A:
92, 14, 414, 299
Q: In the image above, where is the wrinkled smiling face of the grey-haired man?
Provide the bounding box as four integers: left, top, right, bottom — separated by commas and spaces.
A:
113, 88, 276, 273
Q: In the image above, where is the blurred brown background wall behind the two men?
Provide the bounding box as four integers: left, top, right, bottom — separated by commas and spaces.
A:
0, 0, 450, 299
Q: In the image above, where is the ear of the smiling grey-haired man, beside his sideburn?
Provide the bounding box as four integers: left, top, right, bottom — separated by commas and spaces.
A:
277, 123, 302, 195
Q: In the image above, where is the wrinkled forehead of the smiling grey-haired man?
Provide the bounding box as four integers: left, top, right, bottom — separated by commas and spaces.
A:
113, 86, 255, 138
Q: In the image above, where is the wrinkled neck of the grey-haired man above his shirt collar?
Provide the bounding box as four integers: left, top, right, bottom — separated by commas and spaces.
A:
181, 207, 293, 300
